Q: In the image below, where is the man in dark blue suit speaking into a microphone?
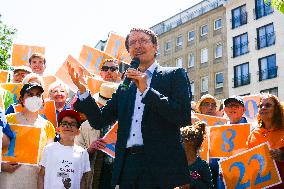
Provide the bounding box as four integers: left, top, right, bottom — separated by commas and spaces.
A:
68, 28, 191, 189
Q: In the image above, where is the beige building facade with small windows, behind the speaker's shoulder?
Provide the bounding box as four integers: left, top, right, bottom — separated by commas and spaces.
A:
151, 0, 228, 101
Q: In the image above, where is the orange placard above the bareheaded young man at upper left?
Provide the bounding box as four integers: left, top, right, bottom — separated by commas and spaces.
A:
11, 44, 45, 66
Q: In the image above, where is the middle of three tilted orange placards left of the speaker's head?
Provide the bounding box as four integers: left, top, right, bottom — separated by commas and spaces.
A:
79, 45, 112, 74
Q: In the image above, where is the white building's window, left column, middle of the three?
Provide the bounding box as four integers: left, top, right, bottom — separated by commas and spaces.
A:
233, 33, 248, 57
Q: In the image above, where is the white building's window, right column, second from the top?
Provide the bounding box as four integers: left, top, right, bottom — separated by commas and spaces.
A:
257, 23, 275, 49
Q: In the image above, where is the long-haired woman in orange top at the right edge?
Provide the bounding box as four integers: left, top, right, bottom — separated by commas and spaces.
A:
247, 94, 284, 189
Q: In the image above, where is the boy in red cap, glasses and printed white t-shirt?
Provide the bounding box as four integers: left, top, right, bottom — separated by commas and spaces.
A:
38, 110, 90, 189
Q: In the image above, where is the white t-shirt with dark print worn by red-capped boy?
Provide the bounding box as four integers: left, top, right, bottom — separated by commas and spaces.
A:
39, 142, 90, 189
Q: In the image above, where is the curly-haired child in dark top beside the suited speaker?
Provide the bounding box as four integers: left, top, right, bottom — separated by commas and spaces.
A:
181, 121, 213, 189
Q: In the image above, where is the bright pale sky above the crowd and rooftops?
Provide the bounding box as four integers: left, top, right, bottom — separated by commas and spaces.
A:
0, 0, 201, 74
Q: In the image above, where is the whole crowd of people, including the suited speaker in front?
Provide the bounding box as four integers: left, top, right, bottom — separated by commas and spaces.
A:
0, 28, 284, 189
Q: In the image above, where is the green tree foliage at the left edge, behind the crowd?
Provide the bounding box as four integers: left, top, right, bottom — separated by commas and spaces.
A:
0, 20, 17, 70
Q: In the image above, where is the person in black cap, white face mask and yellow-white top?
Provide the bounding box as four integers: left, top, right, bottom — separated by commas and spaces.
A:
0, 83, 55, 189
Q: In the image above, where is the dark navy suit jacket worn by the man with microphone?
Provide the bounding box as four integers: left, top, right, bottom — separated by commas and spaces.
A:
74, 66, 191, 187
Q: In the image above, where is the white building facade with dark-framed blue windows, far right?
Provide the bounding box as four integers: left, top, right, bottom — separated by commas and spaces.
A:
225, 0, 284, 101
